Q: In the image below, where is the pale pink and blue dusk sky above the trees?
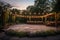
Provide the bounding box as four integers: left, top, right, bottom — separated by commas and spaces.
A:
2, 0, 34, 10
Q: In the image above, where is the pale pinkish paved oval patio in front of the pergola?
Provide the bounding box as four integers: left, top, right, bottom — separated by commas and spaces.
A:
7, 24, 57, 32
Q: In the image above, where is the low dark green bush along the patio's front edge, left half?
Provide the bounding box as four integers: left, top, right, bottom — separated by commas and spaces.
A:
6, 30, 27, 37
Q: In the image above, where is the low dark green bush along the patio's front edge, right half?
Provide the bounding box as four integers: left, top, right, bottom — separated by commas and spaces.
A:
30, 30, 56, 37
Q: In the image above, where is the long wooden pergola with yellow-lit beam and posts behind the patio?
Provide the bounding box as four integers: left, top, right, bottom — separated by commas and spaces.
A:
15, 12, 57, 25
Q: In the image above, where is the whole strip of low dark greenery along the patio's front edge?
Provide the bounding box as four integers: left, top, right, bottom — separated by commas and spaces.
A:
6, 30, 60, 37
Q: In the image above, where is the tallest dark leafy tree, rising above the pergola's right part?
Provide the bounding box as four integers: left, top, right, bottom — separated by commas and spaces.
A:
35, 0, 56, 13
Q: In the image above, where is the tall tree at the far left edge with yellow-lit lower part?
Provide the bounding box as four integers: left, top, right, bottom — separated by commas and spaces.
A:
0, 2, 11, 26
